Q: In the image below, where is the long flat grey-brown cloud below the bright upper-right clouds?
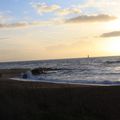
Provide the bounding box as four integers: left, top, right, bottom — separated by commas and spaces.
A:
66, 14, 117, 23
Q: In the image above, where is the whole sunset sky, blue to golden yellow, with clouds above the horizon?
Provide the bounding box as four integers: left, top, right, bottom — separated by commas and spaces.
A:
0, 0, 120, 61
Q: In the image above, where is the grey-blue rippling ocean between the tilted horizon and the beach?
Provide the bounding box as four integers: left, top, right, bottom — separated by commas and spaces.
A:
0, 56, 120, 85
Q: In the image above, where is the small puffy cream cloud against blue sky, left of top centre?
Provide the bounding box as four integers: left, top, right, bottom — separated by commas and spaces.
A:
32, 3, 60, 14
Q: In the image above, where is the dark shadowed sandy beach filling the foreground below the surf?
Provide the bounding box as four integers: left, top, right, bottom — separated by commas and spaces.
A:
0, 71, 120, 120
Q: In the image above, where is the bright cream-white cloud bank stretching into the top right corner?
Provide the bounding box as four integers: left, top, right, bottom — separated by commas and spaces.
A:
30, 0, 120, 16
